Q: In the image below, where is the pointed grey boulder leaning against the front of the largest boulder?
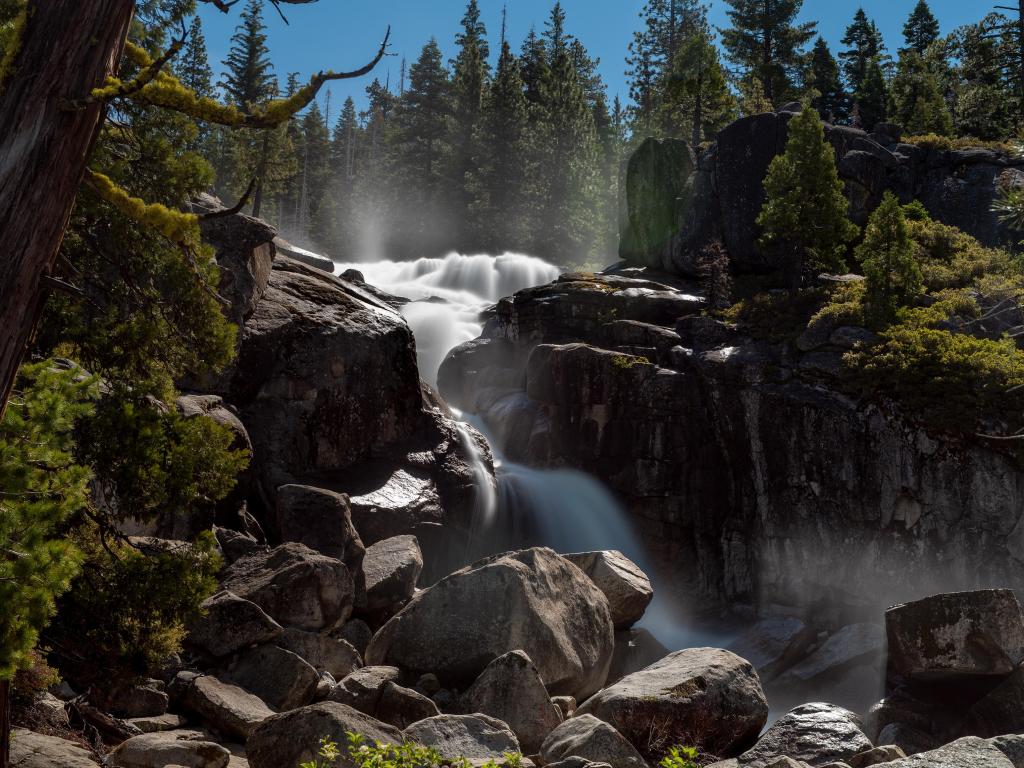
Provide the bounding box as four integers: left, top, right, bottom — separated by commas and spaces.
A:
462, 650, 562, 755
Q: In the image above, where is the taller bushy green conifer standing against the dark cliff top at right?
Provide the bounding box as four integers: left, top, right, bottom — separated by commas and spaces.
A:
758, 105, 857, 283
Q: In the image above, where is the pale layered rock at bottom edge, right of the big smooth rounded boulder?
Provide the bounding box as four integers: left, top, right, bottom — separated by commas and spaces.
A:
739, 703, 871, 768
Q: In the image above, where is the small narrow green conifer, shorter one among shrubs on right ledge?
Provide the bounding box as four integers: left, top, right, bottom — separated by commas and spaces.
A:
856, 191, 924, 324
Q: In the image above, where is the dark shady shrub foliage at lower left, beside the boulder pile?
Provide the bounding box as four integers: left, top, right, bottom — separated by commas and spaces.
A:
45, 526, 221, 691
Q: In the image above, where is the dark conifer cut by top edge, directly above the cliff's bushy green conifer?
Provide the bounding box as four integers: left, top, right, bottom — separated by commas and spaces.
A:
721, 0, 817, 105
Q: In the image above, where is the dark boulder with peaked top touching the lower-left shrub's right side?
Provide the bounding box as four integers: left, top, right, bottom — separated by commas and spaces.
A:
186, 590, 284, 658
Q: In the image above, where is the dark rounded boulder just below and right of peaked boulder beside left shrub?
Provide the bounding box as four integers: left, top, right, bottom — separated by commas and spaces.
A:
223, 645, 319, 711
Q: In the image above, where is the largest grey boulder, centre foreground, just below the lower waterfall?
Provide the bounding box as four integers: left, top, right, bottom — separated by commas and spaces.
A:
367, 548, 614, 698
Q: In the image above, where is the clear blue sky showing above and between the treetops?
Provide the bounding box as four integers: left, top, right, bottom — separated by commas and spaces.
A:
195, 0, 987, 115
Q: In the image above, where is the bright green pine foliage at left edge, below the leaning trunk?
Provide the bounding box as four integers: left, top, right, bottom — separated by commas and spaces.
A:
0, 360, 95, 680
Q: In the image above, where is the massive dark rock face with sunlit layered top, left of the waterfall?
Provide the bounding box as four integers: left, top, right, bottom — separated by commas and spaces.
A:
230, 258, 423, 499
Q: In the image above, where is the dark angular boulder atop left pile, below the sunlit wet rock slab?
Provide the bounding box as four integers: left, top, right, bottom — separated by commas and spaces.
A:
274, 484, 366, 573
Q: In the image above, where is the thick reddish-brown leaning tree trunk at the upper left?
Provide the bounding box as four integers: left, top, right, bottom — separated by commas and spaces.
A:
0, 0, 134, 417
